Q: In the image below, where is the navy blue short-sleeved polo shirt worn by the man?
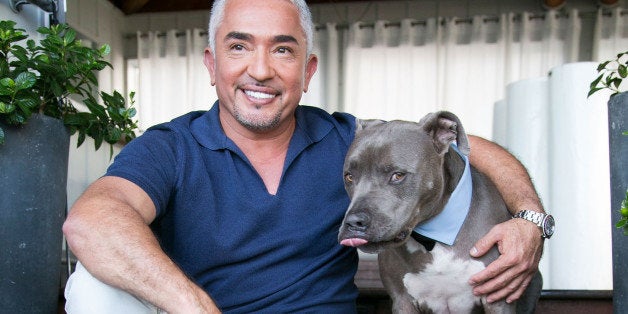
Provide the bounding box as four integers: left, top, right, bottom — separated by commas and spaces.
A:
107, 103, 357, 313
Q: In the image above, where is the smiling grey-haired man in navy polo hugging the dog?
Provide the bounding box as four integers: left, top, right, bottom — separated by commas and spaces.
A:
64, 0, 543, 313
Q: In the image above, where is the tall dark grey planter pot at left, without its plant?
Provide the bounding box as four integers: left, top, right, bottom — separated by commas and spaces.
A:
0, 115, 70, 313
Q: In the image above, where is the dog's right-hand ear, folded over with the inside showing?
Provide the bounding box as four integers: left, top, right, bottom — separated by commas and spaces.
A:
419, 111, 470, 156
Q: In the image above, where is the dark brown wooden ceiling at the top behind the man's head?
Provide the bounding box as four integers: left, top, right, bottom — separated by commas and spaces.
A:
109, 0, 372, 15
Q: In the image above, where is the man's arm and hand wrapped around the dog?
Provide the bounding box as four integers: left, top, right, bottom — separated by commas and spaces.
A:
469, 136, 544, 302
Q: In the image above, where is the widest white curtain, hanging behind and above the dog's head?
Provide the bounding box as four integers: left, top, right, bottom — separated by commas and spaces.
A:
343, 11, 580, 138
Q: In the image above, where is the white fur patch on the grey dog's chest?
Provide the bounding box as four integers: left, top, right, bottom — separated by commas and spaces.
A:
403, 243, 484, 313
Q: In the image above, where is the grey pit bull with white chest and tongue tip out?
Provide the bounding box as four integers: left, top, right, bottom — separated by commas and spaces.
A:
338, 111, 542, 313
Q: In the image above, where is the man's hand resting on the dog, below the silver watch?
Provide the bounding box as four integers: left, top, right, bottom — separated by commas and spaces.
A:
469, 219, 543, 303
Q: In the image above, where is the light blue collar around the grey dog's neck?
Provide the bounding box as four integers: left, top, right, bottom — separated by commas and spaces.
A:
414, 144, 473, 245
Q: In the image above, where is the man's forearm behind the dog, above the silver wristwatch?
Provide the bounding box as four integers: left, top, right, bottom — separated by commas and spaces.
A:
469, 136, 544, 214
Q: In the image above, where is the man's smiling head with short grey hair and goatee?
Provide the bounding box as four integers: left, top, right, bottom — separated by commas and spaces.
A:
205, 0, 317, 132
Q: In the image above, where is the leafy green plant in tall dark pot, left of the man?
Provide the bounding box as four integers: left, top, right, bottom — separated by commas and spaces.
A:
0, 21, 137, 313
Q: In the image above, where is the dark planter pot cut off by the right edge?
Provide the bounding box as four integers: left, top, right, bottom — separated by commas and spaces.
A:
608, 92, 628, 313
